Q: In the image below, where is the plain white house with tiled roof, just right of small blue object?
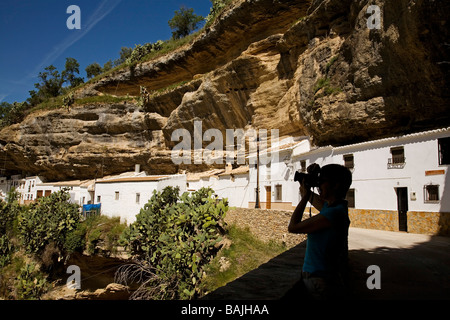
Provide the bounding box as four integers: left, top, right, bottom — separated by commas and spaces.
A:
94, 175, 186, 224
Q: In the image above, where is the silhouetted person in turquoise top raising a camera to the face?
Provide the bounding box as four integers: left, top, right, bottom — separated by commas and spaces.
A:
288, 164, 352, 300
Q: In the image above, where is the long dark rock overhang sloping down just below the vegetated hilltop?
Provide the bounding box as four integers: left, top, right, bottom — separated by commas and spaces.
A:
81, 0, 312, 96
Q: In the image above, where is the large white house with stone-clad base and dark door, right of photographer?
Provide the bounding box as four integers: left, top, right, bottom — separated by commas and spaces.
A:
293, 128, 450, 233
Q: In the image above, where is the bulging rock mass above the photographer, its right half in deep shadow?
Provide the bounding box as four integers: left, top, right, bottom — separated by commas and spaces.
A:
279, 1, 450, 145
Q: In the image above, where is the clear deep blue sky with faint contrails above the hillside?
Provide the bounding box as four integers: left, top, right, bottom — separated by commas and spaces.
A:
0, 0, 211, 103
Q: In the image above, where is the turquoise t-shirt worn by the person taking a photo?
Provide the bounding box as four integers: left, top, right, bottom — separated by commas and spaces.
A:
303, 201, 350, 277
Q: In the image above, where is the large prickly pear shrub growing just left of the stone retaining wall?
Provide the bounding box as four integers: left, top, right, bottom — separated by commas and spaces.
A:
118, 187, 228, 299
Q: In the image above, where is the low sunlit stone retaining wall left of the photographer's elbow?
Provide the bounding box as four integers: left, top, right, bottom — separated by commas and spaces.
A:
225, 208, 306, 248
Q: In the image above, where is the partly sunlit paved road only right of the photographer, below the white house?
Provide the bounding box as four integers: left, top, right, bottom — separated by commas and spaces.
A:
349, 228, 450, 300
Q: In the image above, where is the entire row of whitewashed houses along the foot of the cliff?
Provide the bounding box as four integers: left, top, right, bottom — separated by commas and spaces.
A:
0, 127, 450, 235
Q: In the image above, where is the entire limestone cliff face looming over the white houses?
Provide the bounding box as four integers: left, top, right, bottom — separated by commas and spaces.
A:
0, 0, 450, 180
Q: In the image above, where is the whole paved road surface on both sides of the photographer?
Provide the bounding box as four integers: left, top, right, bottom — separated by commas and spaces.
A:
205, 228, 450, 300
